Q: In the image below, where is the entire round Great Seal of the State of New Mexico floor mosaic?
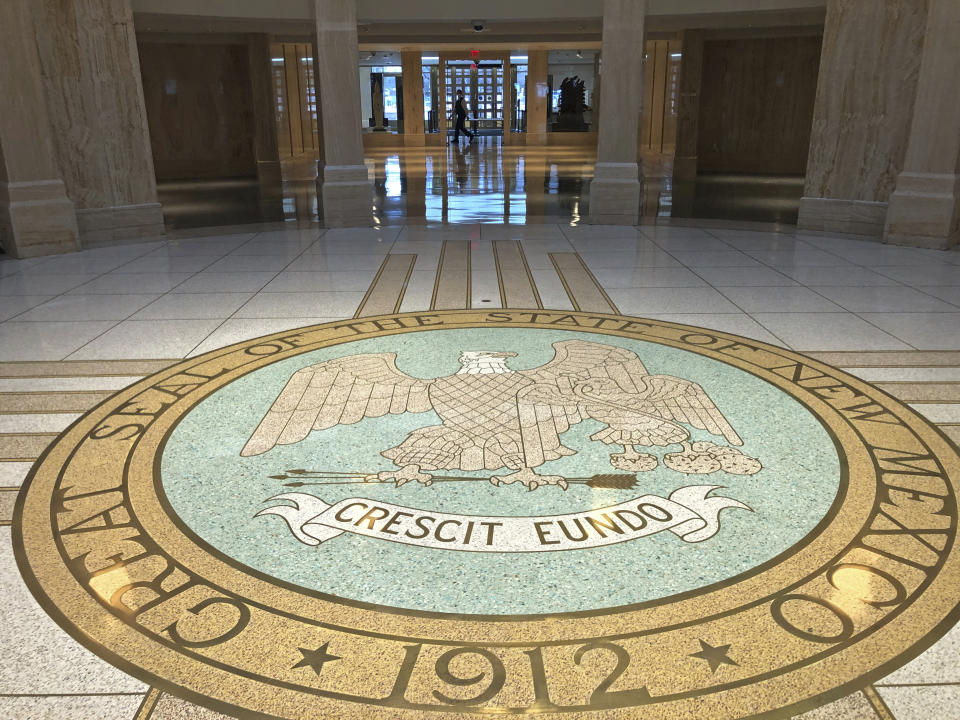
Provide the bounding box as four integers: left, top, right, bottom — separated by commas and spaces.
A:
14, 310, 960, 718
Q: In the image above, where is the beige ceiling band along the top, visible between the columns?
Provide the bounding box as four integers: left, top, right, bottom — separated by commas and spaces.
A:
133, 0, 826, 43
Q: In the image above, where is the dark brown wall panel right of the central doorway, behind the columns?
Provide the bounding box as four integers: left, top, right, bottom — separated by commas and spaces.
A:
697, 36, 821, 175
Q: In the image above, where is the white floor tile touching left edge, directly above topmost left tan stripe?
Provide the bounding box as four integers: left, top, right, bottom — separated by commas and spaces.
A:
0, 320, 115, 361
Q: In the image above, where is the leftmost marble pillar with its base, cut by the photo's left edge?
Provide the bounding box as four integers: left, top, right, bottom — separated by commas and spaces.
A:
0, 0, 78, 258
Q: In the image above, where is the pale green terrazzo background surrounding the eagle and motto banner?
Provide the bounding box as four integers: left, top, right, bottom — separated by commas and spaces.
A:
162, 328, 840, 615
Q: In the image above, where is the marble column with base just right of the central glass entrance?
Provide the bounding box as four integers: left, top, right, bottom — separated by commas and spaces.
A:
588, 0, 647, 225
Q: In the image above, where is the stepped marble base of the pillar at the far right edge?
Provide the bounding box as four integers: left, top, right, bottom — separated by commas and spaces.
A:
883, 172, 960, 250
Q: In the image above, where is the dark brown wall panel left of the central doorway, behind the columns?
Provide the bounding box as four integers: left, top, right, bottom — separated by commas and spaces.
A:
140, 42, 257, 180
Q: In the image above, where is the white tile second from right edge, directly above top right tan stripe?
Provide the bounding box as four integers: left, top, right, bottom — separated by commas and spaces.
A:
752, 313, 911, 351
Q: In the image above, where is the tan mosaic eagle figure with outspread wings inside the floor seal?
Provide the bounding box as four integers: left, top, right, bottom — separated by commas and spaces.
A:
240, 340, 762, 490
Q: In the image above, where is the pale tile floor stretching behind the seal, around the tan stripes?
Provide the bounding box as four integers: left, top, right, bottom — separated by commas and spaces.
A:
0, 225, 960, 361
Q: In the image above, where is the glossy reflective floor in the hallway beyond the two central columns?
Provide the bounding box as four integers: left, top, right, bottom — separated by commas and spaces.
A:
159, 136, 803, 228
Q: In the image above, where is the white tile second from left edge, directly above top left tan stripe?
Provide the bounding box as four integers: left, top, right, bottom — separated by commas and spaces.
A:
69, 319, 223, 360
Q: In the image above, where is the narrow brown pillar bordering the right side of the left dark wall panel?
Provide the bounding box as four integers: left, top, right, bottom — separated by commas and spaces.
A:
247, 33, 282, 185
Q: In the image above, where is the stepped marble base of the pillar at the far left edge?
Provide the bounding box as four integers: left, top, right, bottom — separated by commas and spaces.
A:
0, 180, 80, 258
